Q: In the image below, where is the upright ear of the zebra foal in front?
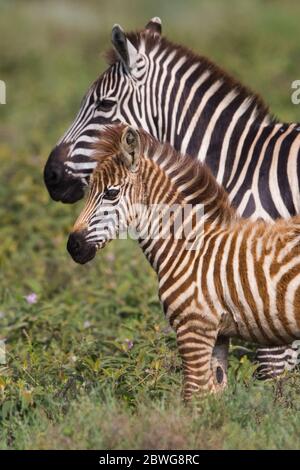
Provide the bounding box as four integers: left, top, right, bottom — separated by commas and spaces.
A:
120, 126, 141, 171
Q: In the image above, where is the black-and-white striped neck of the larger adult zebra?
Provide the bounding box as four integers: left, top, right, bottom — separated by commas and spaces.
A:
156, 51, 275, 173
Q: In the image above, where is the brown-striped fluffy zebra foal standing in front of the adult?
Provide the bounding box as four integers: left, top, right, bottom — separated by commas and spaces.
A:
67, 124, 300, 400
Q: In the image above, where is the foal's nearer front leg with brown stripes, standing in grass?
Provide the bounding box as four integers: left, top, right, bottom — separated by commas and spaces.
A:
177, 325, 220, 401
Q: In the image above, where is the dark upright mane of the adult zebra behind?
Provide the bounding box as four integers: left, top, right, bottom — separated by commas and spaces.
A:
106, 30, 278, 123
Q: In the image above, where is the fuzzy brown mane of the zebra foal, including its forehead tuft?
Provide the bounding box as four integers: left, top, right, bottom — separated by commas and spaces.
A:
93, 124, 236, 220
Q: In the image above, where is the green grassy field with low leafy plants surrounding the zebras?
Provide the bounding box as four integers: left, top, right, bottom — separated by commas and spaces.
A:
0, 0, 300, 449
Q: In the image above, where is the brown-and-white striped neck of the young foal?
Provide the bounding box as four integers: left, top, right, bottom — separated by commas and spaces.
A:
138, 158, 238, 277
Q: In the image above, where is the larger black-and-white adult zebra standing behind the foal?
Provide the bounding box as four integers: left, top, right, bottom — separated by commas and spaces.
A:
44, 18, 300, 378
